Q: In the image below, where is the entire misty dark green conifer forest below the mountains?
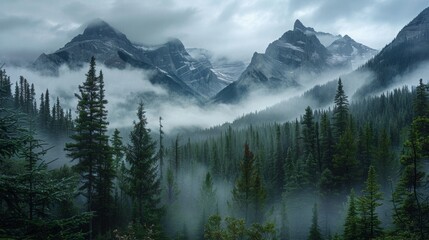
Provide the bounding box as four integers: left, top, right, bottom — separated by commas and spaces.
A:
0, 57, 429, 240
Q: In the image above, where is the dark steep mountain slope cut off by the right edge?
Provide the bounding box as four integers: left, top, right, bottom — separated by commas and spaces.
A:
357, 8, 429, 96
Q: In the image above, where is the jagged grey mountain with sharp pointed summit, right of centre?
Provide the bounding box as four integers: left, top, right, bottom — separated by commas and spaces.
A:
213, 20, 375, 103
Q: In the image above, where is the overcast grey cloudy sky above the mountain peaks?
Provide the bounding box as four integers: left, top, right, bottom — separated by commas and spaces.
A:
0, 0, 429, 60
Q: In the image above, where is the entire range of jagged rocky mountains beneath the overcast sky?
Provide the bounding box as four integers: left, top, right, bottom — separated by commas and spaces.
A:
32, 5, 429, 110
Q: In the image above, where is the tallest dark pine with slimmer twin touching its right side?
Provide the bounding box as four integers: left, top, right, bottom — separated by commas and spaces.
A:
65, 57, 114, 239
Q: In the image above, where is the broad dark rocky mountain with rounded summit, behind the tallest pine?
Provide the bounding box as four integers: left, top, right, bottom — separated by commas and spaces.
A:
32, 19, 228, 102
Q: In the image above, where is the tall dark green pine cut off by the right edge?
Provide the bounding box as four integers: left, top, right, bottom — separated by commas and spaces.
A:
393, 82, 429, 239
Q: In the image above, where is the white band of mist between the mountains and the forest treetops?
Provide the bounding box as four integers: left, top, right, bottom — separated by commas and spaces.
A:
7, 65, 354, 133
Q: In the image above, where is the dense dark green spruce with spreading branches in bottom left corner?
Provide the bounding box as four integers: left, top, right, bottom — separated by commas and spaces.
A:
0, 127, 91, 239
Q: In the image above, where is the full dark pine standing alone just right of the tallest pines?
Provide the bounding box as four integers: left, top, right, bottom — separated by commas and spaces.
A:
126, 102, 161, 233
